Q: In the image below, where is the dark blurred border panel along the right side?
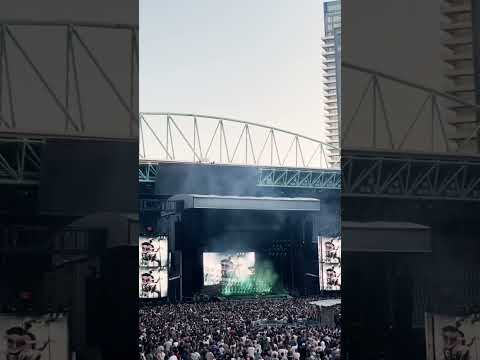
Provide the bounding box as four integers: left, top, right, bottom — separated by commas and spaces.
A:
342, 0, 480, 359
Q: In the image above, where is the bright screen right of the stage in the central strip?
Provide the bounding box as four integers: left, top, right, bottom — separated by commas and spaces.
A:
318, 236, 342, 290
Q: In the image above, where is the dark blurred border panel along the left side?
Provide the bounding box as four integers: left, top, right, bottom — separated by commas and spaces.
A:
0, 0, 139, 360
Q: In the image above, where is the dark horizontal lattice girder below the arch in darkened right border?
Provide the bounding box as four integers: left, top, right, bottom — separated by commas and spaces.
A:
342, 151, 480, 201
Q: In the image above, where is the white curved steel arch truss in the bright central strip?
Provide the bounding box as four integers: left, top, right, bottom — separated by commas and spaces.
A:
139, 112, 339, 168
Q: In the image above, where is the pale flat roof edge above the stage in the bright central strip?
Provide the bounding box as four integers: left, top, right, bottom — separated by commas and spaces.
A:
169, 194, 320, 211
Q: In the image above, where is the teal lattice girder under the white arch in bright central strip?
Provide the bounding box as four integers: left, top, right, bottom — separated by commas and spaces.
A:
257, 168, 341, 190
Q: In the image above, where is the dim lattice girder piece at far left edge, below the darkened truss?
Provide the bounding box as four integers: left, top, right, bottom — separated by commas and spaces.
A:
0, 138, 45, 185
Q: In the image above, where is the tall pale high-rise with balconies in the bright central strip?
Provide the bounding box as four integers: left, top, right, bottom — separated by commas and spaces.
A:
323, 0, 341, 165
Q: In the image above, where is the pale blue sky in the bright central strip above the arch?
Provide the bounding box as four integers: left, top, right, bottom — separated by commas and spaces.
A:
140, 0, 323, 139
